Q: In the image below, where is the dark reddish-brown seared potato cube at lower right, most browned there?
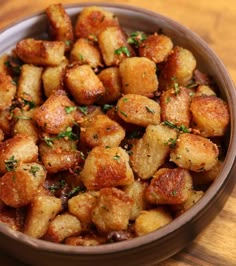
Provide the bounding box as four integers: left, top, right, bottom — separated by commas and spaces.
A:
145, 168, 193, 204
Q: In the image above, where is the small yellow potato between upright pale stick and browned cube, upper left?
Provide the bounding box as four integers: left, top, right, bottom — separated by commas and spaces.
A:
42, 57, 68, 98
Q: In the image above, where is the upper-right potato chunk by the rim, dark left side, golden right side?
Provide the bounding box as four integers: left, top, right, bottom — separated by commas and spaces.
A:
159, 46, 196, 90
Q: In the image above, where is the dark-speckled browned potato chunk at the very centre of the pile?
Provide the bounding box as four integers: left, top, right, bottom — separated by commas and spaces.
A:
80, 115, 125, 148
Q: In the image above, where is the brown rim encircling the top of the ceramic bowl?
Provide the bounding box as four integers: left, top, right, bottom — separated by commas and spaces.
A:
0, 2, 236, 255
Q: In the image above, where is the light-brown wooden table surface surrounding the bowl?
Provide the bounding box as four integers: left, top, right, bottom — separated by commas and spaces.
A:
0, 0, 236, 266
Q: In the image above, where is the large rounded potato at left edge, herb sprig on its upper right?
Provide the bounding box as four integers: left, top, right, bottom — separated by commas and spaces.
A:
0, 163, 46, 208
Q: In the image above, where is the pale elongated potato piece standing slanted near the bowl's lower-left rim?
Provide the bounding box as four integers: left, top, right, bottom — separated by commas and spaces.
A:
24, 195, 62, 238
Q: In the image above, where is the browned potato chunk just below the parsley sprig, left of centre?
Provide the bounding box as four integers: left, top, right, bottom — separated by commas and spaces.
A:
39, 138, 80, 173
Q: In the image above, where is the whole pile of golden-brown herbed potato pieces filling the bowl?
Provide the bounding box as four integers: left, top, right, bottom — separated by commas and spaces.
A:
0, 4, 230, 246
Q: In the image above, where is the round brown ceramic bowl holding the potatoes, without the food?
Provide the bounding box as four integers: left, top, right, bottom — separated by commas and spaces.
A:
0, 3, 236, 266
